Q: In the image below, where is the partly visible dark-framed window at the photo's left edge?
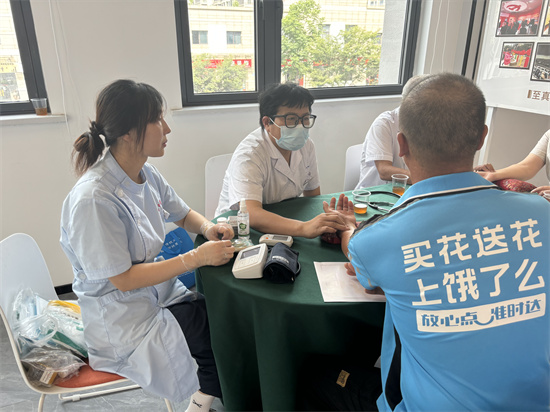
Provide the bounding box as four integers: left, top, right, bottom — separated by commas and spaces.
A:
0, 0, 46, 115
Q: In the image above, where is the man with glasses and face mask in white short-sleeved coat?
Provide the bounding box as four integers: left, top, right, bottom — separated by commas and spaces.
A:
216, 83, 344, 238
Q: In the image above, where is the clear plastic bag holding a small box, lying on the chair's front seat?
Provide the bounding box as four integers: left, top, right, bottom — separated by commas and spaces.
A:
21, 348, 85, 387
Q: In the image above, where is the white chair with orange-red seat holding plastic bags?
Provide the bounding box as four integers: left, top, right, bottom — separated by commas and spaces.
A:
0, 233, 172, 412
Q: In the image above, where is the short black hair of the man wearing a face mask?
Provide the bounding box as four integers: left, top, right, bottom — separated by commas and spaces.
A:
259, 83, 315, 129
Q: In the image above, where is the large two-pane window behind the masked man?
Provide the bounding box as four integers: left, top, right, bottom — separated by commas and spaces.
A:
175, 0, 420, 106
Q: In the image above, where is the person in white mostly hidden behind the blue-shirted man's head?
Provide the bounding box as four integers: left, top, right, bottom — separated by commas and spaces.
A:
356, 74, 426, 189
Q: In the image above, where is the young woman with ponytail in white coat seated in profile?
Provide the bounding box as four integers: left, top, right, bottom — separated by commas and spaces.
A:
61, 80, 234, 411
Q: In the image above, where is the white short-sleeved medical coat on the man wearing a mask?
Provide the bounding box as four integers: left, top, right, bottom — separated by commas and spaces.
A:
216, 128, 320, 216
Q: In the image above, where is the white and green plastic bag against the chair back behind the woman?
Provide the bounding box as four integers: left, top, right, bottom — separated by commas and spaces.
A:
13, 288, 88, 358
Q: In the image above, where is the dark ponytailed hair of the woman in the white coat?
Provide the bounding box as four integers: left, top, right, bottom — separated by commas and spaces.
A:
73, 79, 165, 174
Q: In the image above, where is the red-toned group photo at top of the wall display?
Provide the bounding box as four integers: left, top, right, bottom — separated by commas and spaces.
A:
496, 0, 543, 37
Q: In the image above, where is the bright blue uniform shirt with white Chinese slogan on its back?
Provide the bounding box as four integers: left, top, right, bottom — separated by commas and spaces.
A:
349, 173, 550, 411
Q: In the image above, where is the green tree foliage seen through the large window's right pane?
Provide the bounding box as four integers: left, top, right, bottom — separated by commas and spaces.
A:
281, 0, 381, 87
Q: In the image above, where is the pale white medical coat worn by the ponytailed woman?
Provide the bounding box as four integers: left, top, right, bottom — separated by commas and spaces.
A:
61, 152, 199, 402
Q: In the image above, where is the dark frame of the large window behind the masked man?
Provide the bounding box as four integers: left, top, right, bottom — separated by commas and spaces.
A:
174, 0, 422, 107
